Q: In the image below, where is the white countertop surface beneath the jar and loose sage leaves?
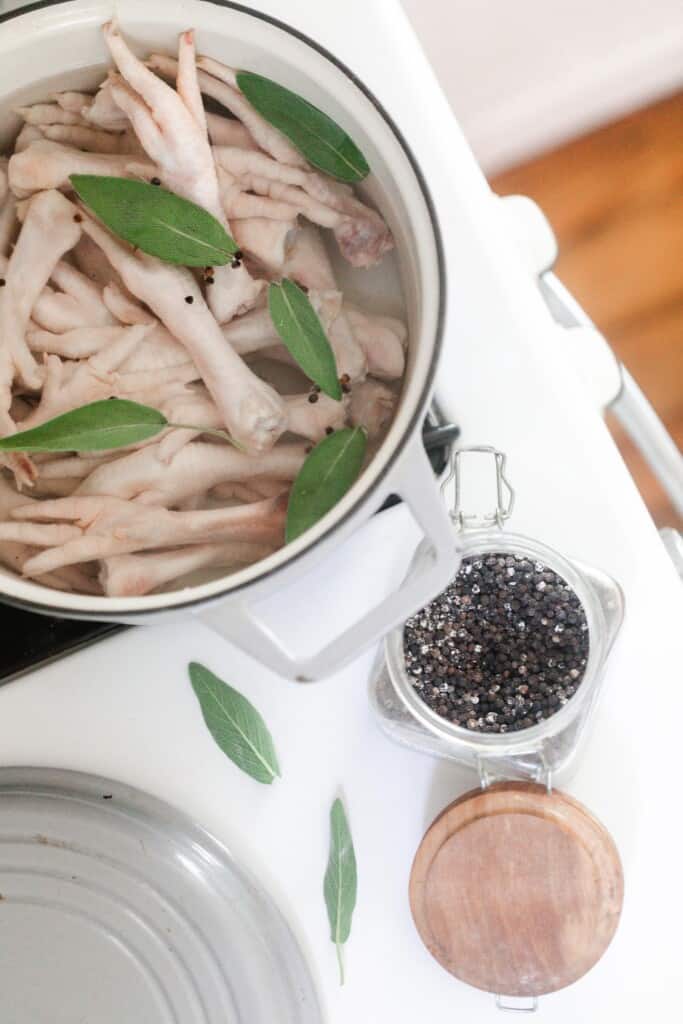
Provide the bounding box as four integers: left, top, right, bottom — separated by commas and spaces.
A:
0, 0, 683, 1024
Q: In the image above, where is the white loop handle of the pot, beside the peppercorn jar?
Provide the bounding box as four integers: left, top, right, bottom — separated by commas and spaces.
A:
200, 437, 460, 683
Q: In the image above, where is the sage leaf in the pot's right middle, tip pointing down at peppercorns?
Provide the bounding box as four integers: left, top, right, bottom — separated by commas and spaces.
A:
268, 278, 342, 401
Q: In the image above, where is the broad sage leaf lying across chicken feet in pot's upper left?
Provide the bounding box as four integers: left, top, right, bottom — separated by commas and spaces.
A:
70, 174, 238, 266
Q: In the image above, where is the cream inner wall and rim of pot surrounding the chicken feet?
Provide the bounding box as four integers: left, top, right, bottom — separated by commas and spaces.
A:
0, 0, 442, 617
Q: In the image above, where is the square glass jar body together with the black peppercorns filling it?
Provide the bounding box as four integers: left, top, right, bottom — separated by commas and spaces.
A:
371, 527, 623, 778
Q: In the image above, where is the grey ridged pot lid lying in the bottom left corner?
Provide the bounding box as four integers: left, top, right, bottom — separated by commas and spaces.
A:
0, 768, 322, 1024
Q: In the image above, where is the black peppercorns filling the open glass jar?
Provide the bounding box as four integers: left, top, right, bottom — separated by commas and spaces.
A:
403, 552, 589, 732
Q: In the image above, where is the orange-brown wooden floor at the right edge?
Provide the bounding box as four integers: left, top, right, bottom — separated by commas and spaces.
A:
492, 93, 683, 526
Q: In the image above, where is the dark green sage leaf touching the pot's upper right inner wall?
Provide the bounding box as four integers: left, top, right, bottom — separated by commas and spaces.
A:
237, 71, 370, 182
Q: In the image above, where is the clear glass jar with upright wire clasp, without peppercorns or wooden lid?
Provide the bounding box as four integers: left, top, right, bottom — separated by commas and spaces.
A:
371, 446, 624, 787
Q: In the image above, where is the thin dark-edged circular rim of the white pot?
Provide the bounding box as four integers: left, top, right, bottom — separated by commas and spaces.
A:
0, 0, 446, 622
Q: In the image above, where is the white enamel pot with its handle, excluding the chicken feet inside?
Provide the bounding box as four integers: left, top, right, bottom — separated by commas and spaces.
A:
0, 0, 457, 681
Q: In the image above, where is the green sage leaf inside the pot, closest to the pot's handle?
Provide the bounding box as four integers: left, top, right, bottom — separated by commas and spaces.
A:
285, 427, 368, 543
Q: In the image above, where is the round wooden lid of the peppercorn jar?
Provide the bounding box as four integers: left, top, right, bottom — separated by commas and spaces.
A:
410, 782, 624, 995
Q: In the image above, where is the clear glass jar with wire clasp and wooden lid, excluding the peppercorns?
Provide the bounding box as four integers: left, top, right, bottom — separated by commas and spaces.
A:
371, 447, 624, 1011
